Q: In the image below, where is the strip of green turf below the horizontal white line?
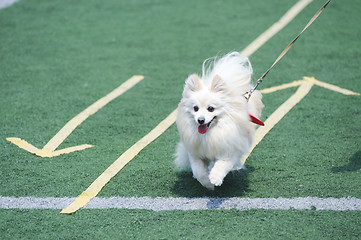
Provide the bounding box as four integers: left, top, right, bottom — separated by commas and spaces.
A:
0, 209, 361, 239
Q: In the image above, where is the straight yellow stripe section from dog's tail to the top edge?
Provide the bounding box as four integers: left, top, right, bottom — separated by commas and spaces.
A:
241, 0, 313, 56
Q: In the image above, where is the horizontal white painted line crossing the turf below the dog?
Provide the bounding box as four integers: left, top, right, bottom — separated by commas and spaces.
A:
0, 197, 361, 211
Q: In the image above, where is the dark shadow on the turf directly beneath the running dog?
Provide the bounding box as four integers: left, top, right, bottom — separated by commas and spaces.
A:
172, 166, 254, 198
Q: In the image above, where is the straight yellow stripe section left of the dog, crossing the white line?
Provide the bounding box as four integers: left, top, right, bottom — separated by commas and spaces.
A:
60, 109, 177, 214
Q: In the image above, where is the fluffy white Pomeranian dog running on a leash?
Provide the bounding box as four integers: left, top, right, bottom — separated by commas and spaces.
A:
175, 52, 263, 190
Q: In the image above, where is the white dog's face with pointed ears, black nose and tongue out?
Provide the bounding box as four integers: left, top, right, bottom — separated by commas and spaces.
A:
183, 75, 225, 134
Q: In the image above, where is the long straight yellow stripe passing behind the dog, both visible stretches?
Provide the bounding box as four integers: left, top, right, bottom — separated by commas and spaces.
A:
61, 0, 312, 214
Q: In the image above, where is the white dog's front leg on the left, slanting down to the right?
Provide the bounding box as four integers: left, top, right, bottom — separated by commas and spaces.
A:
189, 154, 214, 190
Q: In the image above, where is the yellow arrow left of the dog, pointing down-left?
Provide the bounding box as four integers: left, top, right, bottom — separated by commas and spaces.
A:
6, 75, 144, 157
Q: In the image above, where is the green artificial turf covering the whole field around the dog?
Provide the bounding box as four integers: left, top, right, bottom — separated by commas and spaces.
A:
0, 0, 361, 239
